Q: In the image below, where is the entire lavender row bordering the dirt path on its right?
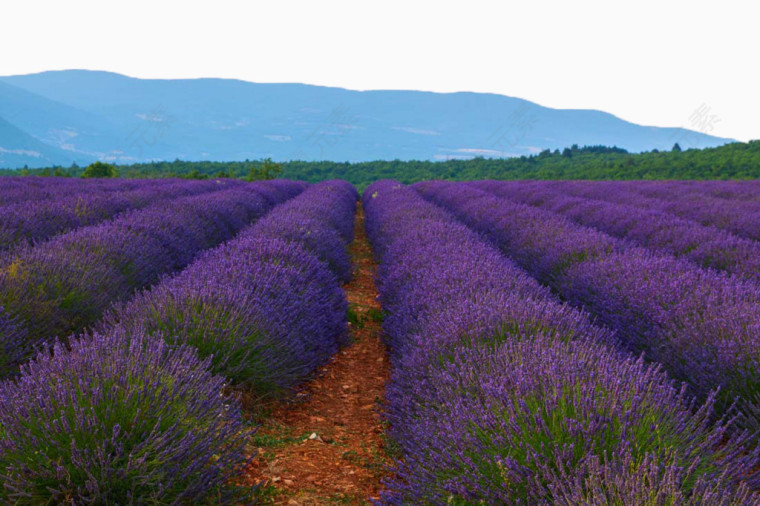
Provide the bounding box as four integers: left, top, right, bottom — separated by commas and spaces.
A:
364, 181, 760, 504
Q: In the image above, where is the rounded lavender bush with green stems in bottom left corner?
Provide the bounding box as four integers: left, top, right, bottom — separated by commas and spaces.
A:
0, 331, 249, 504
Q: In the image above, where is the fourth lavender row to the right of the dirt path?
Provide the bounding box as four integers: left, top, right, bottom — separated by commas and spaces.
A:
536, 181, 760, 240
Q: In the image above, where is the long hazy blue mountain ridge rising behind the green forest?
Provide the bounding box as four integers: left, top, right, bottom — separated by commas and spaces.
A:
0, 70, 730, 167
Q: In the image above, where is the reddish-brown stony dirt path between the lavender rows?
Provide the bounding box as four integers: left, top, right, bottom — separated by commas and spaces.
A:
247, 207, 389, 505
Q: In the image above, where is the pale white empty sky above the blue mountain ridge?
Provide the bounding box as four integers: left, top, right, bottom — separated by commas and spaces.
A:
0, 0, 760, 140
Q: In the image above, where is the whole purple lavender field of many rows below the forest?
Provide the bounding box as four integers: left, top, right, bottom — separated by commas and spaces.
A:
0, 177, 760, 505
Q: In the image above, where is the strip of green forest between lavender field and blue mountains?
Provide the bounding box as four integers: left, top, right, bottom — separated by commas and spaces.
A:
5, 141, 760, 188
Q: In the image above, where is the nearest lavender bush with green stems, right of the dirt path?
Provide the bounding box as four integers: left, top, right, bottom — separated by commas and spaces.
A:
389, 330, 760, 504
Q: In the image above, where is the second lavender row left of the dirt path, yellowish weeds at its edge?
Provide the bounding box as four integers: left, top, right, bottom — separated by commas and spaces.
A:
0, 181, 304, 376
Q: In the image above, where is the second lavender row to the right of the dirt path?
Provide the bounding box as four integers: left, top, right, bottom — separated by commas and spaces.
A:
415, 182, 760, 430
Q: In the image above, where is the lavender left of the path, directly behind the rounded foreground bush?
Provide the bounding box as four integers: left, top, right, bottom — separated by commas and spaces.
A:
100, 182, 357, 396
